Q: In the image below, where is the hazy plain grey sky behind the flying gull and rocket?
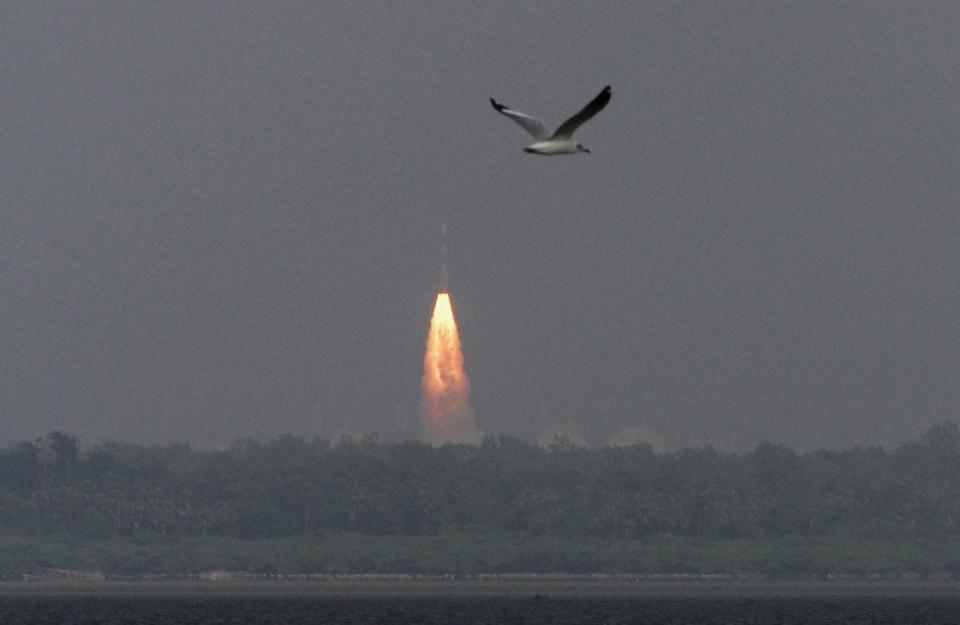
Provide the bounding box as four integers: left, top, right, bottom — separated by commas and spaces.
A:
0, 2, 960, 449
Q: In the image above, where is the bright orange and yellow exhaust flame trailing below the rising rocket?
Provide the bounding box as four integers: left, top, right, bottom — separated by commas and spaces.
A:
422, 291, 481, 445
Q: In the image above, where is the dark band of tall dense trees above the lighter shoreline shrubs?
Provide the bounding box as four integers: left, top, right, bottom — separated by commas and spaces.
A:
0, 422, 960, 573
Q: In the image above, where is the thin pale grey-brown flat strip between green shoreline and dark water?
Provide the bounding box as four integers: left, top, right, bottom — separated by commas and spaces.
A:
0, 574, 960, 599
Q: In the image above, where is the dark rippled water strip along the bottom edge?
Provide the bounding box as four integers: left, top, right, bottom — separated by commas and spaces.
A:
0, 596, 960, 625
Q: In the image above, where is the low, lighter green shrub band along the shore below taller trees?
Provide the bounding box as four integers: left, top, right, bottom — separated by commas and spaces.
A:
0, 533, 960, 584
